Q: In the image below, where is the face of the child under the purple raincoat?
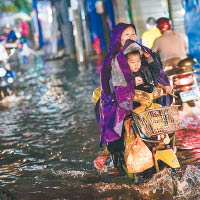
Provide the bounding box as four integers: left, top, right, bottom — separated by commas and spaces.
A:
127, 54, 141, 72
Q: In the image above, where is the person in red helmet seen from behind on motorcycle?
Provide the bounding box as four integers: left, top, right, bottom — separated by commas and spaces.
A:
152, 17, 188, 69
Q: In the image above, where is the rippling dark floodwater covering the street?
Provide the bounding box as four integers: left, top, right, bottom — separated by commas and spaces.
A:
0, 56, 200, 200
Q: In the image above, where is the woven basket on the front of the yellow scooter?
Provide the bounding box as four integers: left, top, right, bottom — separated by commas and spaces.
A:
132, 105, 181, 137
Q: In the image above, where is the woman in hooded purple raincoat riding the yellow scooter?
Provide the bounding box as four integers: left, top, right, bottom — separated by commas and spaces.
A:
95, 23, 172, 170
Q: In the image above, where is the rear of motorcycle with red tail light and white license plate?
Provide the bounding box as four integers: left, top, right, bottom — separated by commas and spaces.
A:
165, 57, 200, 107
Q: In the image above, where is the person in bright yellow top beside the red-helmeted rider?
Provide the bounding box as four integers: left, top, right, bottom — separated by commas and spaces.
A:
142, 17, 161, 49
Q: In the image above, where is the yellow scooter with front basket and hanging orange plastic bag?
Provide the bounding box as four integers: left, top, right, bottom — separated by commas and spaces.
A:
123, 84, 181, 178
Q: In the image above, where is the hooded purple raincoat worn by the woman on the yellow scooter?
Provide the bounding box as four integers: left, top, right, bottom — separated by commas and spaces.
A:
96, 23, 171, 146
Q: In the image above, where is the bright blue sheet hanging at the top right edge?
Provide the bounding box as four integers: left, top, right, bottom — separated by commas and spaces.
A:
184, 0, 200, 62
